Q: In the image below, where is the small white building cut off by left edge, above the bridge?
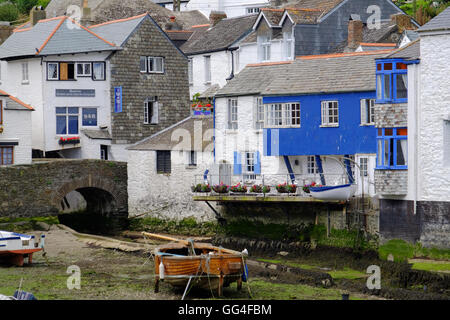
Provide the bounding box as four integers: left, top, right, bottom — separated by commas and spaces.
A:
0, 90, 34, 166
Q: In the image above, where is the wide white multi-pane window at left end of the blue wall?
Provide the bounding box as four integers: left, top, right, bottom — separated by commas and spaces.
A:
264, 102, 301, 128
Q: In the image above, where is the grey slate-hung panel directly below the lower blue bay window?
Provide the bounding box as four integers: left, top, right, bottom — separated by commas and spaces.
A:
375, 170, 408, 195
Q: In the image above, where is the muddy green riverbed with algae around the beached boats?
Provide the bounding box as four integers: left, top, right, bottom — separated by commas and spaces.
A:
0, 225, 448, 300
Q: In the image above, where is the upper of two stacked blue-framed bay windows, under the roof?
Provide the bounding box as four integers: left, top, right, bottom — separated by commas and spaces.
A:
376, 59, 408, 103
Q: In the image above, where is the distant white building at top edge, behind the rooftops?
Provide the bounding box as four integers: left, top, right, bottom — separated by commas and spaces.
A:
186, 0, 270, 18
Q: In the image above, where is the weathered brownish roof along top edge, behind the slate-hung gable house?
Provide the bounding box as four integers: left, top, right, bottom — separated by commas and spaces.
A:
46, 0, 209, 29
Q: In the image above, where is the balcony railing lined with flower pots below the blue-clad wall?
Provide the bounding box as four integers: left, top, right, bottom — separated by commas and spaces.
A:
194, 173, 349, 197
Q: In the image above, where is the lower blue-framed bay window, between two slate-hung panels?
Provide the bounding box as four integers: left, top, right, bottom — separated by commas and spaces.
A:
376, 128, 408, 170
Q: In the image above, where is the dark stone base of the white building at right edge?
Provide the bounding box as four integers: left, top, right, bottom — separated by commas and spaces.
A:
417, 201, 450, 248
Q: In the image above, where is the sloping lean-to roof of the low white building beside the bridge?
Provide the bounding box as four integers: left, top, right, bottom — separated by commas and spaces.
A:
128, 117, 214, 151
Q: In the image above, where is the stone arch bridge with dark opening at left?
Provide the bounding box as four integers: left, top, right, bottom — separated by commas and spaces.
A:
0, 160, 128, 217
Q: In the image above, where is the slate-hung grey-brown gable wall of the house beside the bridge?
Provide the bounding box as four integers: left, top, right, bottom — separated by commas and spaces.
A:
111, 19, 190, 144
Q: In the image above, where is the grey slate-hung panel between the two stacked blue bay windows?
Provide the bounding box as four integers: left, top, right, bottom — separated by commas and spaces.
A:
375, 103, 408, 128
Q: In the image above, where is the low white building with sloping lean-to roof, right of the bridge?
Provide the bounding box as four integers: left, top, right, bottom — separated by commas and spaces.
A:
128, 117, 214, 221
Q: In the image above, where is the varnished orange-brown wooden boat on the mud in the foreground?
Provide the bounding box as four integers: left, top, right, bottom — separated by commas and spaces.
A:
143, 232, 247, 296
